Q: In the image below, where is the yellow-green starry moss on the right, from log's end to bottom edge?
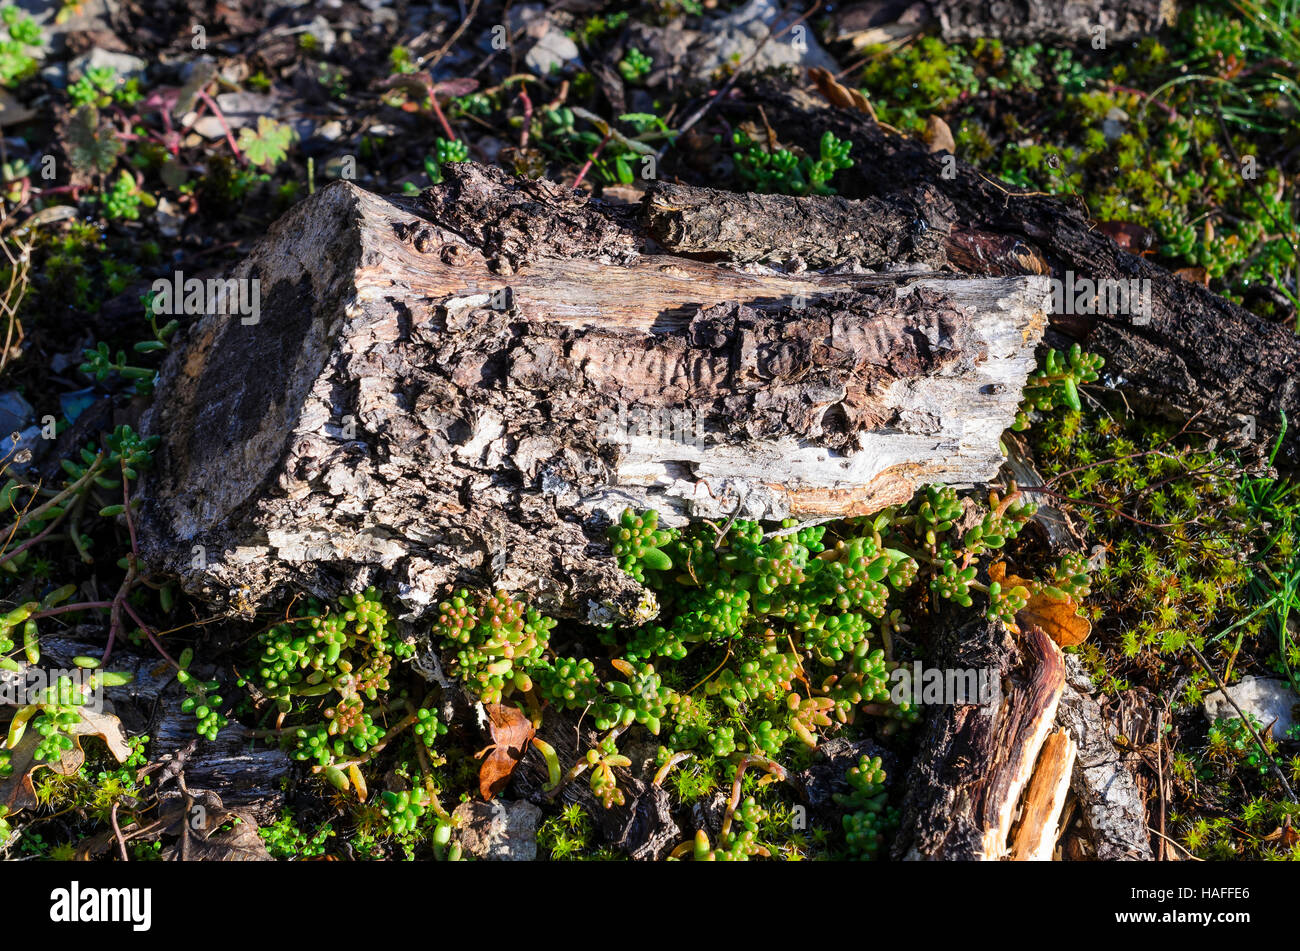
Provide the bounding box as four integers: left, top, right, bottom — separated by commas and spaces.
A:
1034, 381, 1300, 860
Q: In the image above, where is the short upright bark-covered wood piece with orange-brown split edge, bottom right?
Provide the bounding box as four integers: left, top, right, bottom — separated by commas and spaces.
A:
893, 620, 1065, 861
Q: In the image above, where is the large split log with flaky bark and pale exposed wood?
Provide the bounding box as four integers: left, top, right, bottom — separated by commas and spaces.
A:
140, 164, 1049, 621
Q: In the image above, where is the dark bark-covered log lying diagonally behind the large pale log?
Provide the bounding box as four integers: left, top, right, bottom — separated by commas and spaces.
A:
733, 78, 1300, 465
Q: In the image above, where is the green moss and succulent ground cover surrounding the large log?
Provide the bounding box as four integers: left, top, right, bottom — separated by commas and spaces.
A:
0, 0, 1300, 860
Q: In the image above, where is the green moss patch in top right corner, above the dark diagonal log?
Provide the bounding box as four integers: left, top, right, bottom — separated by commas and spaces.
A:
861, 3, 1300, 318
